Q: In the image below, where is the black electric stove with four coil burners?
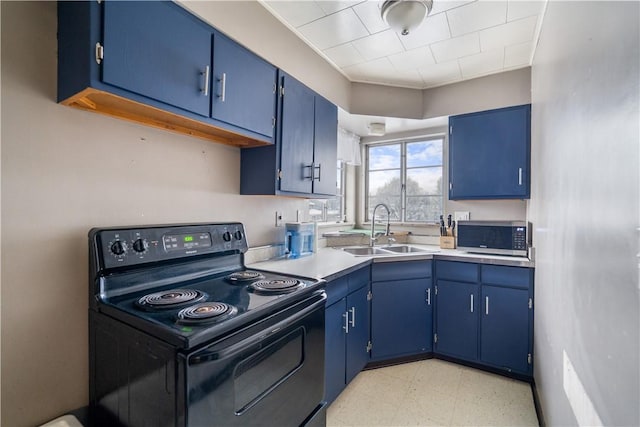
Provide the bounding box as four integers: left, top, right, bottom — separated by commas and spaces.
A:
89, 223, 326, 426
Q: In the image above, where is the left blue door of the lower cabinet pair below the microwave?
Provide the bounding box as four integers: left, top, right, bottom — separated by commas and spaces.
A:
435, 280, 478, 360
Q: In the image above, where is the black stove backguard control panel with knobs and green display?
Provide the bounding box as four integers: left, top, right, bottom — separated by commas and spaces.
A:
89, 223, 248, 268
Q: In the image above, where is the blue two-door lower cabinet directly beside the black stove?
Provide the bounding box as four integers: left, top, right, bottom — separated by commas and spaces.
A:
324, 267, 370, 403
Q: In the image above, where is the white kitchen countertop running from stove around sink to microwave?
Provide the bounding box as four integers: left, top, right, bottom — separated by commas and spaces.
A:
247, 244, 534, 280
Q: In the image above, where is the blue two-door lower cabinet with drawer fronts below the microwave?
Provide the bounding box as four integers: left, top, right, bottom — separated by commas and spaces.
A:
434, 261, 533, 376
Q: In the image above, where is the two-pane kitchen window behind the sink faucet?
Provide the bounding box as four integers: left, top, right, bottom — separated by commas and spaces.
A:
365, 136, 444, 223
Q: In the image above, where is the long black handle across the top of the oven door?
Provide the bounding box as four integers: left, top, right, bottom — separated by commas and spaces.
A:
188, 292, 327, 366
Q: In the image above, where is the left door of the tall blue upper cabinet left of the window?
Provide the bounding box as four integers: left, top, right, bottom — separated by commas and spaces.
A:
280, 75, 316, 194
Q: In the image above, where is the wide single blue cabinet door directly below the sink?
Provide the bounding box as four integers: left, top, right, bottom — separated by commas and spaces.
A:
371, 279, 431, 360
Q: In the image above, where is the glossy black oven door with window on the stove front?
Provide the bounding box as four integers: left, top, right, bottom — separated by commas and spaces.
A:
185, 292, 326, 427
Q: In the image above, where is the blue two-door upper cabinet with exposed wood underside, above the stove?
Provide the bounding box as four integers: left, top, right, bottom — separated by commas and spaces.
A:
58, 1, 277, 147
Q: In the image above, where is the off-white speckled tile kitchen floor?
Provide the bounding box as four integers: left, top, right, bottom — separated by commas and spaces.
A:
327, 359, 538, 427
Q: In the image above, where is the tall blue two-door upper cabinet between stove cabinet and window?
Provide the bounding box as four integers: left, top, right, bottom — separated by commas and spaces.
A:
240, 71, 338, 197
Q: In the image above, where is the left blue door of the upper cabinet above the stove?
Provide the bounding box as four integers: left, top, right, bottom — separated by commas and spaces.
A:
102, 1, 211, 117
